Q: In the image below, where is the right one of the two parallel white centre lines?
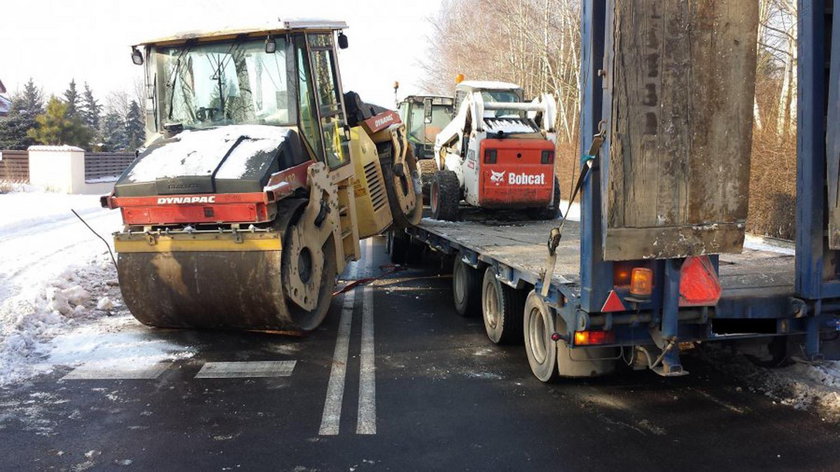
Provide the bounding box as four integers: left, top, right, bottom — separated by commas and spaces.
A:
356, 284, 376, 434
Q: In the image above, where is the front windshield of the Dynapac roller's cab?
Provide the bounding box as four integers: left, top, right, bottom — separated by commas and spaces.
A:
153, 38, 296, 128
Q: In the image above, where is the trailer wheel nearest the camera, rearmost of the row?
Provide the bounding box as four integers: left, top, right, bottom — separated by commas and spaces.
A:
522, 290, 558, 382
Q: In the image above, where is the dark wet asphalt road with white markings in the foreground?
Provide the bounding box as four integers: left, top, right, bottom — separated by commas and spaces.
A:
0, 240, 840, 471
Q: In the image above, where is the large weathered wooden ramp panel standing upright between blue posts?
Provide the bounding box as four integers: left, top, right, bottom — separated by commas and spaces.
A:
603, 0, 758, 260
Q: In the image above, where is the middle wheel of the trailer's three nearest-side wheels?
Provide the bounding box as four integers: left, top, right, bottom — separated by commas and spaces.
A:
481, 267, 525, 344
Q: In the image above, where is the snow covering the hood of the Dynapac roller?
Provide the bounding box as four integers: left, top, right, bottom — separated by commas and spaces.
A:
128, 125, 286, 182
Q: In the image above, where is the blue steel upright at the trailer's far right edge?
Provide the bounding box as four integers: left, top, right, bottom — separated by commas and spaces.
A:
795, 0, 840, 357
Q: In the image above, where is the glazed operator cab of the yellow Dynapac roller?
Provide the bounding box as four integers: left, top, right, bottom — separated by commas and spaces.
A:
132, 21, 350, 170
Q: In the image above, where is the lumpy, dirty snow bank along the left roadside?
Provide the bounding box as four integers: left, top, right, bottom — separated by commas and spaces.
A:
0, 254, 116, 386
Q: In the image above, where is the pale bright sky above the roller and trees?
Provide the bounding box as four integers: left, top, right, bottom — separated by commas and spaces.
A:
0, 0, 442, 107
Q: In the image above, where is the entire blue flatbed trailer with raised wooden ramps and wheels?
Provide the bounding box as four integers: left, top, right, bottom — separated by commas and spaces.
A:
392, 0, 840, 381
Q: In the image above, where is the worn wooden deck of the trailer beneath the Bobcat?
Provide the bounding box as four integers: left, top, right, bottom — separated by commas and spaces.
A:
414, 218, 794, 311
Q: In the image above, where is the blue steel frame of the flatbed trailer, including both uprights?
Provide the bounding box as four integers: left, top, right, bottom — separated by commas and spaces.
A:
408, 0, 840, 375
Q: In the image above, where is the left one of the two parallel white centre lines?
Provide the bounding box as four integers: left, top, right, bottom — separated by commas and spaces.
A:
318, 290, 356, 436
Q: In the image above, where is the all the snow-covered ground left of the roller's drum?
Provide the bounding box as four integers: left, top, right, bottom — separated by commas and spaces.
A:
0, 188, 192, 387
